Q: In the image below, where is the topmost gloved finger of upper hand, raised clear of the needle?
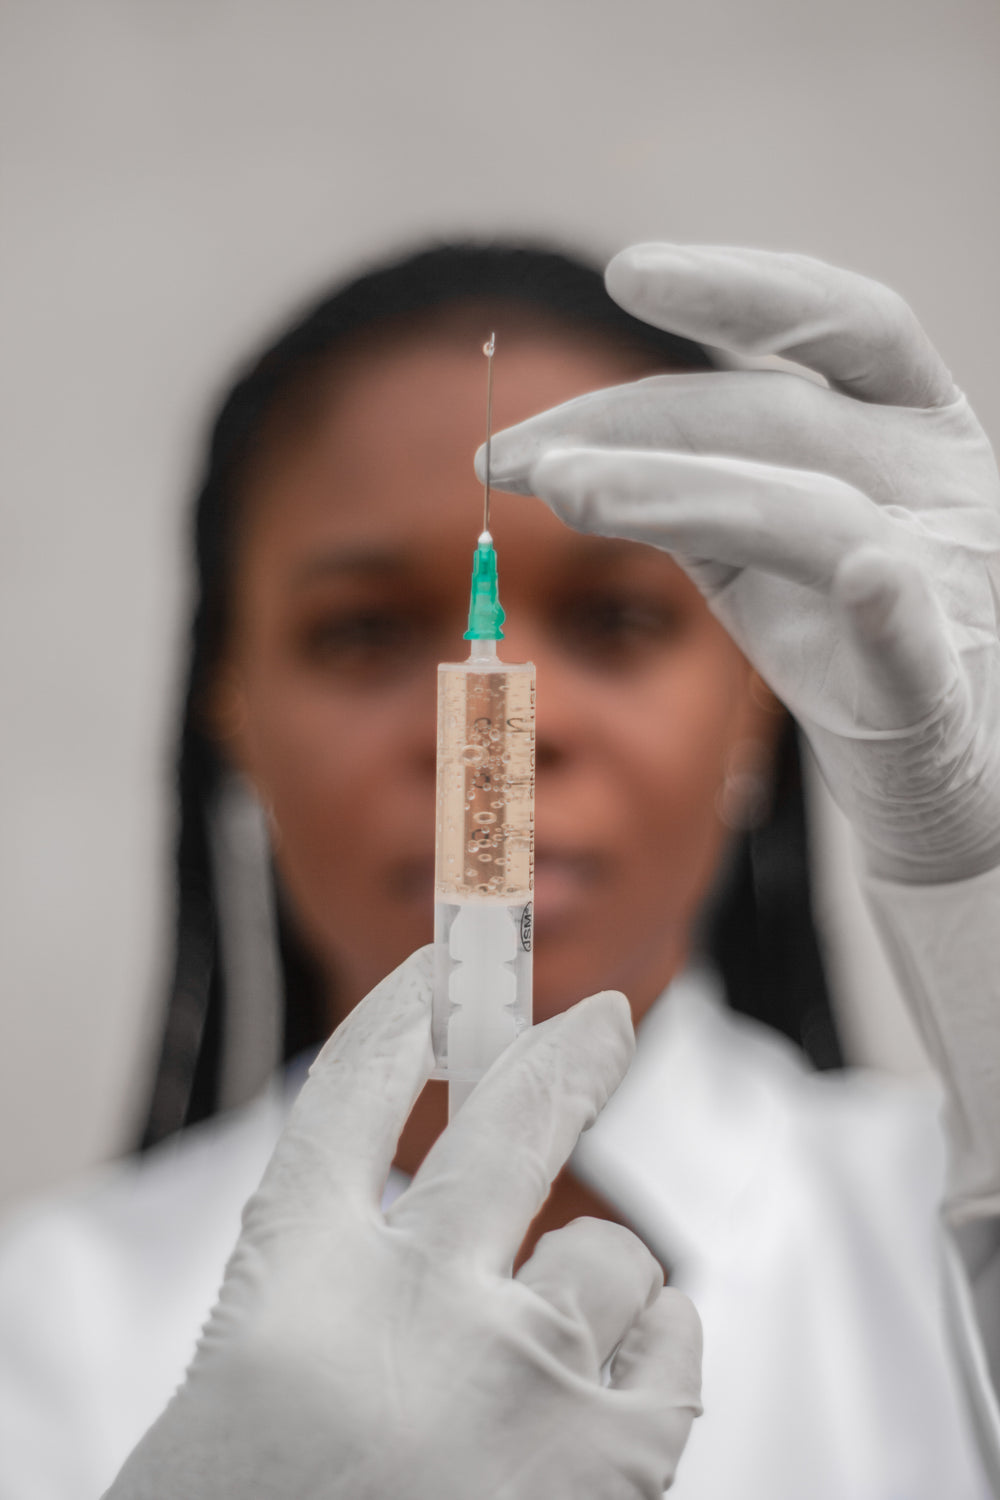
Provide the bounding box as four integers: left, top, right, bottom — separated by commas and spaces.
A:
606, 245, 958, 407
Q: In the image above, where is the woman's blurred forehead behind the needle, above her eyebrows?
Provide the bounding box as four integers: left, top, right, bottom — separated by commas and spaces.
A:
243, 318, 649, 561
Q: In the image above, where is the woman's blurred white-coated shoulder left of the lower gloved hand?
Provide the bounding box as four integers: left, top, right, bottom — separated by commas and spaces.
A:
0, 1092, 285, 1496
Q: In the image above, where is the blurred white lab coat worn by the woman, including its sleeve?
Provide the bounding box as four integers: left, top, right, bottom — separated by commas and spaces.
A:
0, 875, 1000, 1500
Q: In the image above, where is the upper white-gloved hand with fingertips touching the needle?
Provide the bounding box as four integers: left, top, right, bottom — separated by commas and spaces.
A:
477, 245, 1000, 884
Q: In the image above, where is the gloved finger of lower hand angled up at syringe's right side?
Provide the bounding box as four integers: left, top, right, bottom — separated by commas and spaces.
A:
387, 990, 636, 1274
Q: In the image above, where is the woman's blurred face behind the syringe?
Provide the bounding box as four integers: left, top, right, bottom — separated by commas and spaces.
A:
216, 321, 772, 1019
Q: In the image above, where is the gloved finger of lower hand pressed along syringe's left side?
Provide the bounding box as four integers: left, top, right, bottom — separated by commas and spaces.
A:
252, 947, 433, 1217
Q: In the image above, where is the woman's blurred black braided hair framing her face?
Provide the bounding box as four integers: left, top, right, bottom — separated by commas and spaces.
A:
142, 243, 840, 1148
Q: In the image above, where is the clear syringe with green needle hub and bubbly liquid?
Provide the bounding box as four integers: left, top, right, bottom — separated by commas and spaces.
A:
433, 336, 535, 1115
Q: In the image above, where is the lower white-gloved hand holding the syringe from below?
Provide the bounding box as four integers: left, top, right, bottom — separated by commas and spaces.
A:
106, 948, 700, 1500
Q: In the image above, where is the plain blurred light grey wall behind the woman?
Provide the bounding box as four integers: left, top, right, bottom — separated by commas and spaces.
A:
0, 0, 1000, 1199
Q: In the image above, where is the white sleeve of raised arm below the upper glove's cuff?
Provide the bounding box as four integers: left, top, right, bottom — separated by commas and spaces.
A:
865, 870, 1000, 1496
